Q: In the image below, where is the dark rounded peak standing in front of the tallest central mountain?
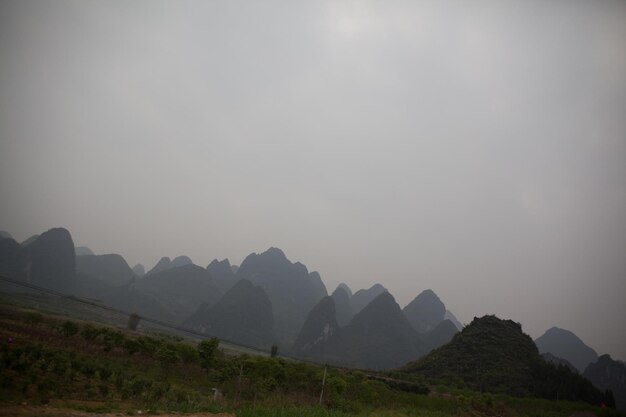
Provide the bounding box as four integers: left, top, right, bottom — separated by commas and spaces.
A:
185, 279, 275, 349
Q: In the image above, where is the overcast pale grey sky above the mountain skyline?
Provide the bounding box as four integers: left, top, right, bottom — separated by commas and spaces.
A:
0, 0, 626, 359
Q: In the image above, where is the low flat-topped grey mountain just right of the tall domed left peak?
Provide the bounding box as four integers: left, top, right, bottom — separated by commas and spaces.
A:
76, 254, 135, 287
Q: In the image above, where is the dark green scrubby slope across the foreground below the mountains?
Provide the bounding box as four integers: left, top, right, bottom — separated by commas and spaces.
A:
0, 305, 619, 417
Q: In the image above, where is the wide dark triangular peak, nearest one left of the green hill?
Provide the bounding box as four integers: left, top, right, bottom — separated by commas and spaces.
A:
325, 291, 427, 369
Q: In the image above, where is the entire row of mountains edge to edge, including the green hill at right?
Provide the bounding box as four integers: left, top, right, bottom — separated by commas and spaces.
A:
0, 228, 624, 404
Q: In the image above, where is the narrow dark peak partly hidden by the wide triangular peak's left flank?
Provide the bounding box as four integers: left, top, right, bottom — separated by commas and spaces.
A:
291, 294, 338, 360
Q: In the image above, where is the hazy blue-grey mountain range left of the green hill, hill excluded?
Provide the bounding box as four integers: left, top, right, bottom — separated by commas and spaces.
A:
0, 224, 464, 360
